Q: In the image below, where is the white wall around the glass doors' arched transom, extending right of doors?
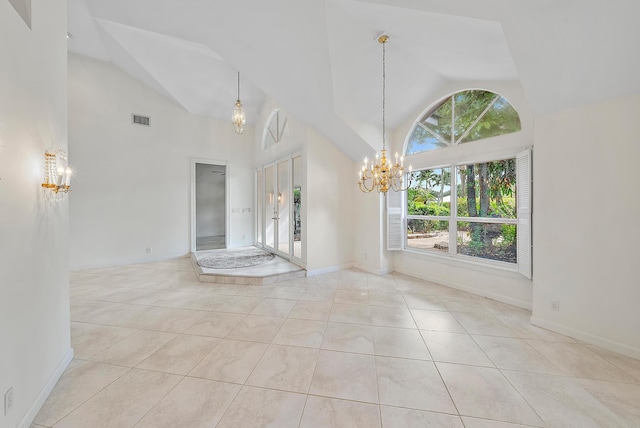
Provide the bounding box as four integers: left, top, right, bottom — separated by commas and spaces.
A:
254, 99, 358, 275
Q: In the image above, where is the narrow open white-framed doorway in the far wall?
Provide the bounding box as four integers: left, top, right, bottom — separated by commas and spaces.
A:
191, 159, 228, 252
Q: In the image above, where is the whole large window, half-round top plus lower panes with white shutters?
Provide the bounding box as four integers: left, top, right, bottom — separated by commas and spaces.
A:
387, 90, 531, 278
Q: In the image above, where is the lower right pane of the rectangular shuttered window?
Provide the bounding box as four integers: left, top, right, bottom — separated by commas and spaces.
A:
456, 221, 518, 263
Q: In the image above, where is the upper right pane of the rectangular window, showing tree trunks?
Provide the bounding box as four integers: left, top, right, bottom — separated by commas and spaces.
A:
456, 159, 516, 218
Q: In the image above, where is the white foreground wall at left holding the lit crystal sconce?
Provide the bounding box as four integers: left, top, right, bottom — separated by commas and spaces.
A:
0, 0, 73, 427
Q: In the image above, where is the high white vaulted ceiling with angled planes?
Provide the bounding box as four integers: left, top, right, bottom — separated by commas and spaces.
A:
68, 0, 640, 160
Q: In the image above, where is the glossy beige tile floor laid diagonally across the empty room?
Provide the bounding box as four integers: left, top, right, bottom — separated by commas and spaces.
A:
33, 258, 640, 428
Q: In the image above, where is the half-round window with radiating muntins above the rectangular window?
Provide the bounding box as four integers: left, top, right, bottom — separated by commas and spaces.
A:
405, 90, 520, 155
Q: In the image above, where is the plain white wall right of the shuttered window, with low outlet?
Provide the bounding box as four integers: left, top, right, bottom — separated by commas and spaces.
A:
532, 95, 640, 357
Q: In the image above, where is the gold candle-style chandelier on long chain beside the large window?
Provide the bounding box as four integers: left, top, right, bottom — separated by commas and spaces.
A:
358, 35, 412, 193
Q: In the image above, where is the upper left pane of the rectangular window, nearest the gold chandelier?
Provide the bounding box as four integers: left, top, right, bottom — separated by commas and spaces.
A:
407, 168, 451, 217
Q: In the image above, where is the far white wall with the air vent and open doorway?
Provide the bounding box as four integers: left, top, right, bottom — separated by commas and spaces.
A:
69, 55, 254, 269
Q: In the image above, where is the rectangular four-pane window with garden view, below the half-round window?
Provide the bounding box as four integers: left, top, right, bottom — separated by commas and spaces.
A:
406, 158, 517, 263
